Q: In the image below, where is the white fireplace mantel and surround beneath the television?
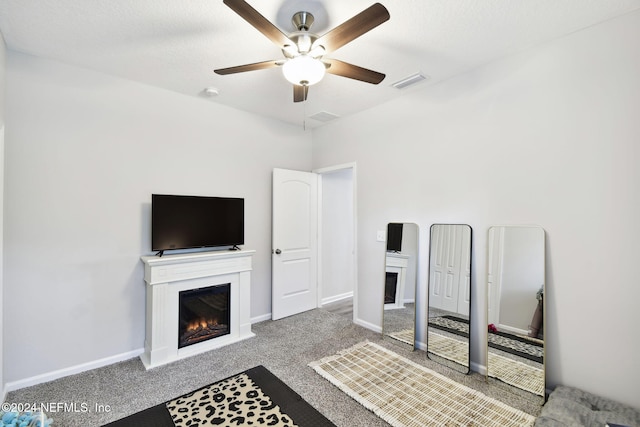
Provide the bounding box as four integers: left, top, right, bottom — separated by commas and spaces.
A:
140, 250, 255, 369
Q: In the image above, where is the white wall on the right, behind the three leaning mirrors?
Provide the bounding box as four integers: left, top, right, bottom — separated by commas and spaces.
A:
313, 13, 640, 407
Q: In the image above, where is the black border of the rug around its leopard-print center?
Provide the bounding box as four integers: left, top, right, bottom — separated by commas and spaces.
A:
103, 365, 336, 427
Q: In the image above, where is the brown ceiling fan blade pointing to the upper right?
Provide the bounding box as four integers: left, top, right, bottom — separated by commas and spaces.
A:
313, 3, 390, 53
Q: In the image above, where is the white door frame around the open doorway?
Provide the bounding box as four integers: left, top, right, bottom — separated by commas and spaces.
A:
312, 162, 358, 321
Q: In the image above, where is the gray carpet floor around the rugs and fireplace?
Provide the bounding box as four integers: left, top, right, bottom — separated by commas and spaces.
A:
6, 309, 540, 427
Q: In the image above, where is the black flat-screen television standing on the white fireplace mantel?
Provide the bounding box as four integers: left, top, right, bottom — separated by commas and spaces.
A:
151, 194, 244, 251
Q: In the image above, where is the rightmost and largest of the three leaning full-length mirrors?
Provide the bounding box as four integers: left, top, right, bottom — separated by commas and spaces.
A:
487, 226, 546, 403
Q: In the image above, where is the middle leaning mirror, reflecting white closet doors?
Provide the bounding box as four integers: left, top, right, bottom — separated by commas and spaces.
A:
427, 224, 471, 373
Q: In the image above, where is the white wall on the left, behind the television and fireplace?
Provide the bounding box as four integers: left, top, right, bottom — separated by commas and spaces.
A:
4, 51, 311, 383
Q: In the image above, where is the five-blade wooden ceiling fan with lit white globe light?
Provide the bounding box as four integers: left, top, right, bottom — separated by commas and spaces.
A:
214, 0, 390, 102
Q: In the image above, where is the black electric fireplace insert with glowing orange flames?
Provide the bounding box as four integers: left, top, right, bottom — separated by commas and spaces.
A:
178, 283, 231, 348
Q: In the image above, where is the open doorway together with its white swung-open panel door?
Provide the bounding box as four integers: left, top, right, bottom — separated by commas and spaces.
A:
271, 164, 357, 320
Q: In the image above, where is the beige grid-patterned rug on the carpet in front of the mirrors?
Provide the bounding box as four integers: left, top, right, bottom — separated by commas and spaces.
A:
309, 341, 535, 427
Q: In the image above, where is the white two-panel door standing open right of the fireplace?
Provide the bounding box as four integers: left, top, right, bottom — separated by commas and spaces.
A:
271, 169, 318, 320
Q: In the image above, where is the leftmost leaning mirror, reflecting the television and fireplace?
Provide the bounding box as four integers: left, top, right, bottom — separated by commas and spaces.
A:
382, 222, 418, 350
